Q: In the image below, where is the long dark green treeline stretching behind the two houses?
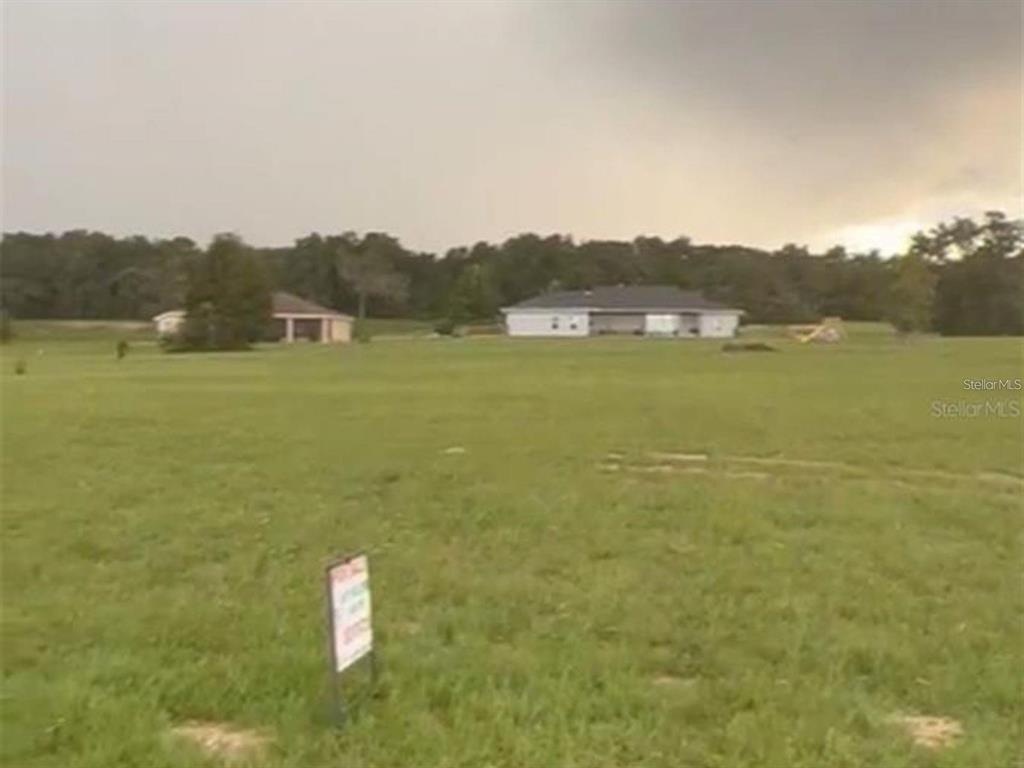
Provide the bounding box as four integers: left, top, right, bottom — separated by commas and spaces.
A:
0, 212, 1024, 335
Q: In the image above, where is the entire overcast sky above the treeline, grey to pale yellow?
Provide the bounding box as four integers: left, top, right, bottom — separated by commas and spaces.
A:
2, 0, 1022, 252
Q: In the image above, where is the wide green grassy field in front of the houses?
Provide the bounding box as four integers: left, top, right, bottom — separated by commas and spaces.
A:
0, 328, 1024, 768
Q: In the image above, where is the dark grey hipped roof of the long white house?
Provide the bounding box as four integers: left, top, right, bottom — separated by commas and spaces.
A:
505, 286, 740, 312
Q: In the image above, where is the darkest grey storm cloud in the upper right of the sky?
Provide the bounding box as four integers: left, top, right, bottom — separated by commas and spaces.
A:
564, 0, 1021, 128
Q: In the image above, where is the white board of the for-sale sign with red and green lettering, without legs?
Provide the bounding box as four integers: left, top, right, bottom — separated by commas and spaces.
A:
328, 555, 374, 672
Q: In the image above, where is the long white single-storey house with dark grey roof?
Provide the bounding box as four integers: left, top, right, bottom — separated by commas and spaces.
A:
502, 286, 743, 339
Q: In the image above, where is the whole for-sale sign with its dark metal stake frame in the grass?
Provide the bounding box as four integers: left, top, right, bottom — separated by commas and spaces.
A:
326, 554, 377, 726
